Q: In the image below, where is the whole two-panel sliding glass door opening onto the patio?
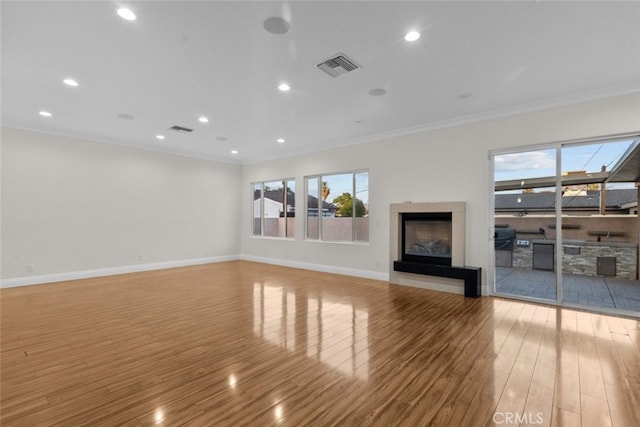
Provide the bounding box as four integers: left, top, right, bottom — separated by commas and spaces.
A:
491, 135, 640, 315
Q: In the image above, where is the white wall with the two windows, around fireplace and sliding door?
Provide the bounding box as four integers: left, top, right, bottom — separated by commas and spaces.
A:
241, 93, 640, 292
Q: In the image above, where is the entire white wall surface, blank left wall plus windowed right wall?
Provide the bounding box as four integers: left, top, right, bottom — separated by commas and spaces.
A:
0, 94, 640, 286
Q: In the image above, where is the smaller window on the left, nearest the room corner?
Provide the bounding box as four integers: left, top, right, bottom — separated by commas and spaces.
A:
251, 179, 296, 238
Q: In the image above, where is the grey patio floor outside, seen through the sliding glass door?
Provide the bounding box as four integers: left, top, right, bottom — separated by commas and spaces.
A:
496, 267, 640, 312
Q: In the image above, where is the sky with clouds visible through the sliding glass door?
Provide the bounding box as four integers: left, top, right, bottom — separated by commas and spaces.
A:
495, 139, 638, 188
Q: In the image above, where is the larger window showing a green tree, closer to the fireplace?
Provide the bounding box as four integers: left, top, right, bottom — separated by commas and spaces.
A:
305, 171, 369, 242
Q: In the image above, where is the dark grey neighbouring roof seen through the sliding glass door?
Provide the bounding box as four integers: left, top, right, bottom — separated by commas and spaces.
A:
495, 188, 638, 211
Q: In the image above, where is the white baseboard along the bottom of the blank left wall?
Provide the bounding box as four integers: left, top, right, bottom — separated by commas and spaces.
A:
0, 255, 240, 288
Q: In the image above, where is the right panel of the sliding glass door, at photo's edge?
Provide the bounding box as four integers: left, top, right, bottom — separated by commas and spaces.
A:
561, 139, 640, 312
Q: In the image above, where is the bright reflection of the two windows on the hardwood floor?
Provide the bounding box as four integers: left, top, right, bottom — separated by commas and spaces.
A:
253, 283, 369, 379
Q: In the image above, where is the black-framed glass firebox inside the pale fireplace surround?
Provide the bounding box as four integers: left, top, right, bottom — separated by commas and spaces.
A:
400, 212, 452, 266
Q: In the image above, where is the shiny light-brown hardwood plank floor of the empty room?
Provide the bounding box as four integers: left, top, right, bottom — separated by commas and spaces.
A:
0, 261, 640, 427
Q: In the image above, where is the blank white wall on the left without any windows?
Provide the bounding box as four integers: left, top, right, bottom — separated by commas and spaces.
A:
1, 128, 240, 286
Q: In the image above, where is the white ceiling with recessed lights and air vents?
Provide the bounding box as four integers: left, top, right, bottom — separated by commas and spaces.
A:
1, 1, 640, 163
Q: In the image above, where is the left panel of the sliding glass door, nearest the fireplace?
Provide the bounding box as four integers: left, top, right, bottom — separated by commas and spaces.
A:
494, 148, 557, 301
